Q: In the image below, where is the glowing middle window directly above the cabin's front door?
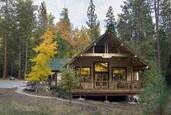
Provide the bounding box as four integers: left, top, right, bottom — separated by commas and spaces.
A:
95, 62, 108, 72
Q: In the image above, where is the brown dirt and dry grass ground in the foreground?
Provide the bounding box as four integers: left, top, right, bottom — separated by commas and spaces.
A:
0, 88, 145, 115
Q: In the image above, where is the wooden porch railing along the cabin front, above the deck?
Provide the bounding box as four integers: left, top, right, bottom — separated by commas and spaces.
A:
80, 81, 143, 90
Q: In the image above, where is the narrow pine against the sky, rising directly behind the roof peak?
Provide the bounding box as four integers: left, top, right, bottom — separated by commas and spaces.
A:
105, 6, 116, 34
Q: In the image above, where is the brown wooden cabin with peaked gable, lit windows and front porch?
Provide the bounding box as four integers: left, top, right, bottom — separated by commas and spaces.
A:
68, 31, 148, 96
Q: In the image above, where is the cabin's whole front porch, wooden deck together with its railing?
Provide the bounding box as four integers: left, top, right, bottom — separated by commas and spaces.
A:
72, 81, 143, 96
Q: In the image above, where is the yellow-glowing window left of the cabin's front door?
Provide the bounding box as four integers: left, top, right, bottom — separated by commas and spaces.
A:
76, 67, 91, 81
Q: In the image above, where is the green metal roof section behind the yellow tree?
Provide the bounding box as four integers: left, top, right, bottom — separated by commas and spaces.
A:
50, 58, 71, 71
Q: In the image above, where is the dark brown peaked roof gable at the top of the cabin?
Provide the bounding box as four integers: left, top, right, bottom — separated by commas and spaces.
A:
67, 31, 147, 67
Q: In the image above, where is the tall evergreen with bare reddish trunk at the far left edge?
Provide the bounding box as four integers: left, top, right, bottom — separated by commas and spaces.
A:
0, 0, 15, 79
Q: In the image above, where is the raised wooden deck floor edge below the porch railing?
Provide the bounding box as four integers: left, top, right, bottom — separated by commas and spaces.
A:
72, 89, 143, 96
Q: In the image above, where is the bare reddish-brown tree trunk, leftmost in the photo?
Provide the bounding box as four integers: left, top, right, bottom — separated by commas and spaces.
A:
2, 36, 7, 79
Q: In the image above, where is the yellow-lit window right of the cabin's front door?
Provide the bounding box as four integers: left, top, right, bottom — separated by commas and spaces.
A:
112, 68, 127, 81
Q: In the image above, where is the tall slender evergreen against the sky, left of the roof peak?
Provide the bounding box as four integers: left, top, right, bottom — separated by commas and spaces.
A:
86, 0, 100, 40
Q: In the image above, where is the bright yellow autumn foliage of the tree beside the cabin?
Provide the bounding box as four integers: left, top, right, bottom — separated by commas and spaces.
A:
27, 29, 57, 81
